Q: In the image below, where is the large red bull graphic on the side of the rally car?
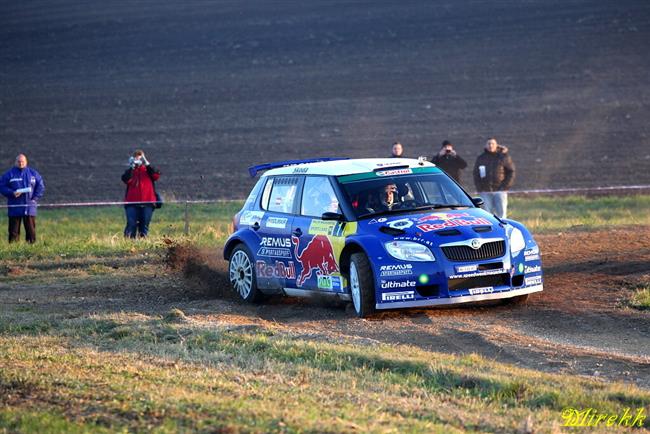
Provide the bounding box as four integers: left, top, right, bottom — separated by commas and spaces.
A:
291, 235, 339, 286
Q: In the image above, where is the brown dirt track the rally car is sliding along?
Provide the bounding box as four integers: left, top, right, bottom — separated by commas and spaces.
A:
0, 229, 650, 388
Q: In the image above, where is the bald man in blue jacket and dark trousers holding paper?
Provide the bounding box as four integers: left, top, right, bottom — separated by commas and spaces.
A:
0, 154, 45, 243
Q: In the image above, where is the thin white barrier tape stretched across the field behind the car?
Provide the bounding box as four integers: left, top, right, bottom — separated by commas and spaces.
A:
0, 185, 650, 208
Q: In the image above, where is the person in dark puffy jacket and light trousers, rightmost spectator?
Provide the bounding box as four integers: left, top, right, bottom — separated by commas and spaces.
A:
473, 137, 515, 218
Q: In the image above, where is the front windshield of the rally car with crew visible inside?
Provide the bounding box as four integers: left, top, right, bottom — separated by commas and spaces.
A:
338, 167, 474, 218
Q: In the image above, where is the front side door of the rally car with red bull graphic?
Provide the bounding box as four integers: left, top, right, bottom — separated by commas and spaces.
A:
291, 176, 345, 292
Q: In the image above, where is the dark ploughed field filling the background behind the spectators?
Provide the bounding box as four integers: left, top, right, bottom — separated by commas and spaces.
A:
0, 0, 650, 202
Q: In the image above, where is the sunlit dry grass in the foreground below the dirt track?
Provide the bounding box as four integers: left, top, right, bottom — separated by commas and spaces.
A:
0, 302, 650, 432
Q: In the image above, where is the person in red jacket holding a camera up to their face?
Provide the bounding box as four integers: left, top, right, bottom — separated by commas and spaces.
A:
122, 149, 160, 238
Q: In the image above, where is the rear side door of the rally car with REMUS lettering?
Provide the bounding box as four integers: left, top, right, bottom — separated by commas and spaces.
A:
254, 176, 302, 289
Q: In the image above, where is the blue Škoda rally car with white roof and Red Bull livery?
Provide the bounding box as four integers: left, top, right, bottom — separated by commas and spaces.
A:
224, 159, 542, 317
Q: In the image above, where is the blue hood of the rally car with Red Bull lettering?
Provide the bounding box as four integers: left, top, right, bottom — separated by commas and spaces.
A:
360, 208, 505, 242
